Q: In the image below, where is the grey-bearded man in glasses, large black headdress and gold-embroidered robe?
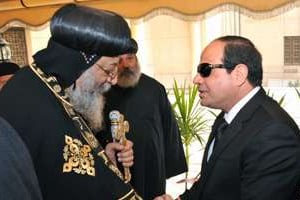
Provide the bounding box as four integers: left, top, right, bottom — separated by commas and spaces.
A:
0, 4, 139, 200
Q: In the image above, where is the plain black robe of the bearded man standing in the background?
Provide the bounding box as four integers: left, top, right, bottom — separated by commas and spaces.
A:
98, 74, 187, 200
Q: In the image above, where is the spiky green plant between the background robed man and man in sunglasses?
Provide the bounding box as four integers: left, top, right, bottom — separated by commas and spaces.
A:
172, 80, 207, 188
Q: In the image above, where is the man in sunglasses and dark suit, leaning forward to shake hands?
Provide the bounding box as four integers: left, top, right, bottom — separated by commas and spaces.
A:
156, 36, 300, 200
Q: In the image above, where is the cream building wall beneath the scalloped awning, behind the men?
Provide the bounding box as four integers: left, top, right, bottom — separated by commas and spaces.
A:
29, 7, 300, 88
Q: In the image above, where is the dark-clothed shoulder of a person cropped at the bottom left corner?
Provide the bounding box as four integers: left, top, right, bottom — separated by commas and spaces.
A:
0, 117, 42, 200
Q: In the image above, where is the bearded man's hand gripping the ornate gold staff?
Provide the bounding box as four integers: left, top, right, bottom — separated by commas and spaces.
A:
105, 140, 134, 167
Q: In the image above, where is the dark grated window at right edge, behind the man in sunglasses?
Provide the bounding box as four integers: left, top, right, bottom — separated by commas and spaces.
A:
284, 36, 300, 65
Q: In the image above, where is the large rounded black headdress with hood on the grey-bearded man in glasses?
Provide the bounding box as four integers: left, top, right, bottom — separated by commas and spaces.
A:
33, 4, 133, 88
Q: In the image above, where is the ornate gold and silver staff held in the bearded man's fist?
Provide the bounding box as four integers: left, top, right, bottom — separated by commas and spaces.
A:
109, 110, 131, 183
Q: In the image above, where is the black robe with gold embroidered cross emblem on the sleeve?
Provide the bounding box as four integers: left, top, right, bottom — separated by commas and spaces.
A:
0, 67, 139, 200
